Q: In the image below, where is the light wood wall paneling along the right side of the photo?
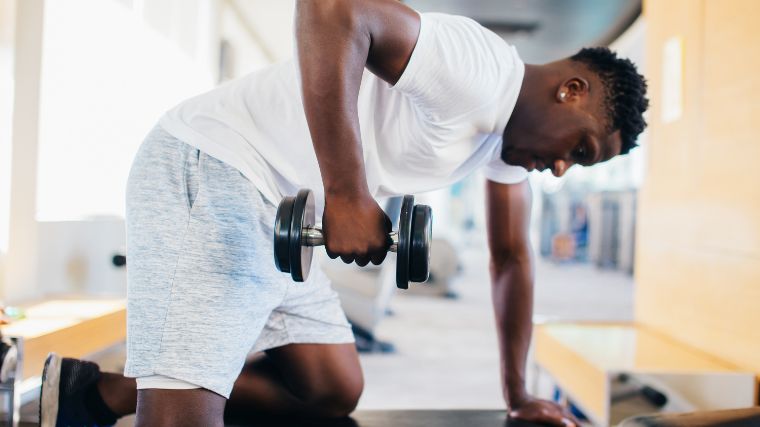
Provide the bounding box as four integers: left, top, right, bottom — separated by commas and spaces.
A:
636, 0, 760, 382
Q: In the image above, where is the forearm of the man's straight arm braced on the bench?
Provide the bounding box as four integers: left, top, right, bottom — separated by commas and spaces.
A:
491, 253, 533, 405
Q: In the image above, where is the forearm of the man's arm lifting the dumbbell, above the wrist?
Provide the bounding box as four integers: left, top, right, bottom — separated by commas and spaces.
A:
296, 0, 370, 195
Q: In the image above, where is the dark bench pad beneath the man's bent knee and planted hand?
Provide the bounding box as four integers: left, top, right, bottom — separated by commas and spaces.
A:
227, 410, 539, 427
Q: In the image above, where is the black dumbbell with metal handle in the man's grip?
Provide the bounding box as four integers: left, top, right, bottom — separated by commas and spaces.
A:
274, 189, 433, 289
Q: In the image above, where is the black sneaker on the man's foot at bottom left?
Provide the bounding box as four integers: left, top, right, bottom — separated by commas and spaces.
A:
40, 353, 116, 427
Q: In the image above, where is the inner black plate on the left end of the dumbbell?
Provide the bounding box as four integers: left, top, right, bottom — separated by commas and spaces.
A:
290, 189, 314, 282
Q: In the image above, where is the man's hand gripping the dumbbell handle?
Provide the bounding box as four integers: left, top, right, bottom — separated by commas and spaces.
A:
322, 195, 391, 267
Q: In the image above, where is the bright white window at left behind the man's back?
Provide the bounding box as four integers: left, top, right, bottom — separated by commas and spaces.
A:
37, 0, 215, 221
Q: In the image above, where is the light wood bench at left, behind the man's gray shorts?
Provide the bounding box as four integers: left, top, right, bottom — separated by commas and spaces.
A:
0, 299, 126, 379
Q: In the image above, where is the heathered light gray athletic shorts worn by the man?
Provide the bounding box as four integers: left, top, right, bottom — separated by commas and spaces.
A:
125, 126, 353, 397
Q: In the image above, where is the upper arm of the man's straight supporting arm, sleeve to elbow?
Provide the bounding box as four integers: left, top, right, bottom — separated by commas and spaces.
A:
486, 179, 532, 266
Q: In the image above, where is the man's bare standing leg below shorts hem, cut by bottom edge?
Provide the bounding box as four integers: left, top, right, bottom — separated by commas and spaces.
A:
135, 389, 226, 427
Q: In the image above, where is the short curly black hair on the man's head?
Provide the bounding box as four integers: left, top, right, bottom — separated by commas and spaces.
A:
570, 47, 649, 154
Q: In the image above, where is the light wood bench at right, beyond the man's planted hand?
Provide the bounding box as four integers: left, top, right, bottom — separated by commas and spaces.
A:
534, 323, 757, 426
